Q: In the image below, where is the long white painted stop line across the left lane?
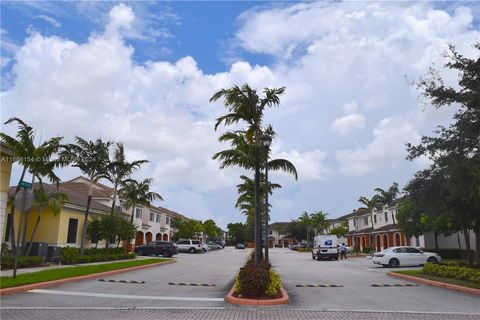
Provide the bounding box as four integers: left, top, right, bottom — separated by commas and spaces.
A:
27, 289, 224, 302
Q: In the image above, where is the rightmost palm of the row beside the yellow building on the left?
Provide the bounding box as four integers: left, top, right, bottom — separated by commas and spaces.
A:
118, 179, 163, 223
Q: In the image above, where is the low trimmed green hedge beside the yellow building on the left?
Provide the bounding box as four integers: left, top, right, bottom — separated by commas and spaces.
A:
60, 247, 136, 264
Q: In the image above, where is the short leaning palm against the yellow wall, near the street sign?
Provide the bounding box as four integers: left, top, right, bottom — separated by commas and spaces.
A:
25, 186, 68, 256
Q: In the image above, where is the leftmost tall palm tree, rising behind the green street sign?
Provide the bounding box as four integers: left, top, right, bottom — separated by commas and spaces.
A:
0, 118, 63, 252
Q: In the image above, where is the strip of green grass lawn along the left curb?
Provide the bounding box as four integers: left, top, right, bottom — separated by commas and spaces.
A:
0, 259, 171, 288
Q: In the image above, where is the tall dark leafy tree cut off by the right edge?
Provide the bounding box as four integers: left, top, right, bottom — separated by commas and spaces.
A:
407, 42, 480, 265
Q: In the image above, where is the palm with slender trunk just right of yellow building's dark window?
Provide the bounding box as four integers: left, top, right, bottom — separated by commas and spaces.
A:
62, 136, 112, 255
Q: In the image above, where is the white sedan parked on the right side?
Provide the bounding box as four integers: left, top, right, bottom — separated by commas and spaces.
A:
372, 247, 442, 268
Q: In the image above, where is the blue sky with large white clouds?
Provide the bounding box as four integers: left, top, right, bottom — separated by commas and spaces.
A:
0, 1, 480, 228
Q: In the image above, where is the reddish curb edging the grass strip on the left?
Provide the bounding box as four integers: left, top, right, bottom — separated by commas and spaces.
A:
0, 260, 176, 296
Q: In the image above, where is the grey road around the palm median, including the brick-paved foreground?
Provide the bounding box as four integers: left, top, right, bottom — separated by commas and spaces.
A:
1, 248, 480, 320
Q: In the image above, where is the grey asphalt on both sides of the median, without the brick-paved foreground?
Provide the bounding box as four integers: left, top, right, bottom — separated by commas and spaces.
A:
2, 247, 480, 315
